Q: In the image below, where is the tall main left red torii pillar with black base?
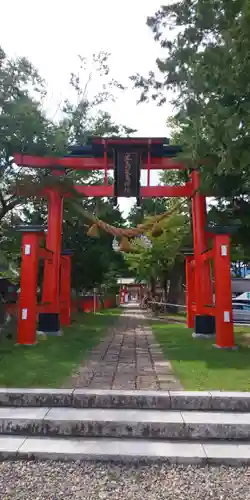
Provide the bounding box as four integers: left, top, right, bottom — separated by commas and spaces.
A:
38, 188, 63, 335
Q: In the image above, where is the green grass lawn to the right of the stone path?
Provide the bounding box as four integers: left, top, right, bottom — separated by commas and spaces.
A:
152, 321, 250, 391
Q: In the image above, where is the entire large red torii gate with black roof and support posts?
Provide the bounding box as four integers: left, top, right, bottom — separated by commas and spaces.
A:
14, 138, 234, 348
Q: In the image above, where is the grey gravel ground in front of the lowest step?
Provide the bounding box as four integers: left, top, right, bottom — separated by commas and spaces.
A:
0, 461, 250, 500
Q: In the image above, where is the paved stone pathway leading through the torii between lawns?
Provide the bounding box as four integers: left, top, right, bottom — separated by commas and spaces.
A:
65, 305, 182, 390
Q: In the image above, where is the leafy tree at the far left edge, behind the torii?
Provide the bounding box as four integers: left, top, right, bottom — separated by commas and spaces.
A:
0, 48, 65, 304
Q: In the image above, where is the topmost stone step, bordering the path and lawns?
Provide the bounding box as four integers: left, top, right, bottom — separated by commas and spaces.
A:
0, 388, 250, 412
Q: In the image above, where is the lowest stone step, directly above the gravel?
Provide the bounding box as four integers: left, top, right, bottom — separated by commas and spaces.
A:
0, 435, 250, 465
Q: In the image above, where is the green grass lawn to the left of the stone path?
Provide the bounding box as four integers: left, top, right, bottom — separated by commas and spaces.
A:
0, 309, 120, 387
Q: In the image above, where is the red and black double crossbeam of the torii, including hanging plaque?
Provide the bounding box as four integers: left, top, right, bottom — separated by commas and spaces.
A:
14, 137, 194, 198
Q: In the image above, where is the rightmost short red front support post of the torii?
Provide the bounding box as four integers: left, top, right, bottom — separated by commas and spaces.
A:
214, 234, 235, 349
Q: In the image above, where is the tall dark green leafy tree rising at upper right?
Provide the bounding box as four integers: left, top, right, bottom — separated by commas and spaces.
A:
132, 0, 250, 270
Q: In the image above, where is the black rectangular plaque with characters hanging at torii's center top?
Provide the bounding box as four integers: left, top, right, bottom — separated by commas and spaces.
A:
114, 150, 141, 199
